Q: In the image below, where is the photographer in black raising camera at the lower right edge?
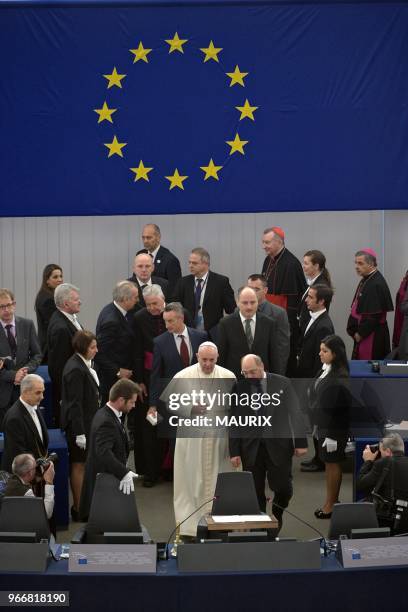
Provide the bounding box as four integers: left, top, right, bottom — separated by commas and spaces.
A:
356, 433, 408, 526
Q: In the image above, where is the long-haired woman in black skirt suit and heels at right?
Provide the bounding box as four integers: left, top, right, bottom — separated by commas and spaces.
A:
309, 334, 351, 519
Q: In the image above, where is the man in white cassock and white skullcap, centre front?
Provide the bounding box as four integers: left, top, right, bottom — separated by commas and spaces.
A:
173, 342, 235, 536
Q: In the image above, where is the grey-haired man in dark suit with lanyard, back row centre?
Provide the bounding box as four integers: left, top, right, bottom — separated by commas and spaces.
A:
173, 247, 236, 342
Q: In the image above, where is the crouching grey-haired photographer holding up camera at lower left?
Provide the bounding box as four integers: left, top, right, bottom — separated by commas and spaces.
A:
4, 454, 55, 519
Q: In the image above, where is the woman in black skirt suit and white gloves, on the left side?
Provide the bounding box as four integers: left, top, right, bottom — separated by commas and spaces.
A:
61, 330, 100, 520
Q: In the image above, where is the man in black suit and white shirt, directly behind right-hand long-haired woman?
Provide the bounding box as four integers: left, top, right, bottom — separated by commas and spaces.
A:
296, 284, 334, 472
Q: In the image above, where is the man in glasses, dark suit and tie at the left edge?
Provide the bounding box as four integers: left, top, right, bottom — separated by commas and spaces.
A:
0, 289, 42, 431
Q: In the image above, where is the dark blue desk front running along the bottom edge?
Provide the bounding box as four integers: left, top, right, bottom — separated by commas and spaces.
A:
0, 556, 408, 612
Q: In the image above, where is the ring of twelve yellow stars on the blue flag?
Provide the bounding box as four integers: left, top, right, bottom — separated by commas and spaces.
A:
93, 32, 259, 191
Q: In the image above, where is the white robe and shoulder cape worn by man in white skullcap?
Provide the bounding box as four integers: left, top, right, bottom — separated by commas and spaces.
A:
174, 363, 235, 536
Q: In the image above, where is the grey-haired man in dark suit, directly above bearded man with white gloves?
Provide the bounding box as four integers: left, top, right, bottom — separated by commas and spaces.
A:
95, 281, 138, 404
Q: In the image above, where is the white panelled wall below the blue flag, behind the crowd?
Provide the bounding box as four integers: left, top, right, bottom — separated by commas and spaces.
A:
0, 210, 408, 354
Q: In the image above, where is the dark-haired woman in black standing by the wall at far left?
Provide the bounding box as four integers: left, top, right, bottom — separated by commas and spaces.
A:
34, 264, 63, 364
